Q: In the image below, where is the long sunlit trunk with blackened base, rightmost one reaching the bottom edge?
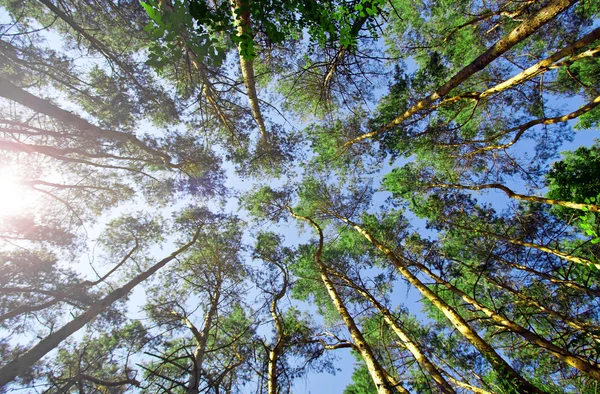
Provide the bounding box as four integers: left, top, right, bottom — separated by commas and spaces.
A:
329, 212, 544, 394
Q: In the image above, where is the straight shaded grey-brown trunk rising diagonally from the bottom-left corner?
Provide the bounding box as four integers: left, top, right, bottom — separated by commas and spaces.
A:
0, 230, 200, 387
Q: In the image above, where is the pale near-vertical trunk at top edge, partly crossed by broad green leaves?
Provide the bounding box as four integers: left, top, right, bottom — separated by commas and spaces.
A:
231, 0, 269, 146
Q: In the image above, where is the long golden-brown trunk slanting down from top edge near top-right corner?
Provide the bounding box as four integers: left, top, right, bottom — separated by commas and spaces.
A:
344, 0, 578, 147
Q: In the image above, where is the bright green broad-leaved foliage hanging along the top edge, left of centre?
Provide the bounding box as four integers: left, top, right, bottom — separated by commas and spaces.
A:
142, 0, 384, 70
